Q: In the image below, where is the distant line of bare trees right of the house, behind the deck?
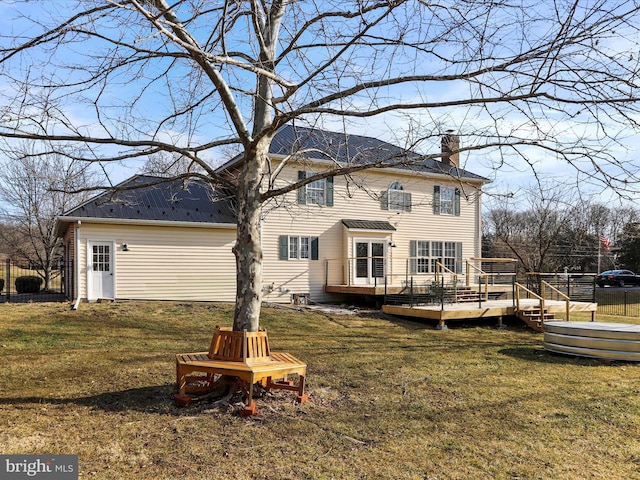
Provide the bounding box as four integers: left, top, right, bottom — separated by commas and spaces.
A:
482, 185, 640, 273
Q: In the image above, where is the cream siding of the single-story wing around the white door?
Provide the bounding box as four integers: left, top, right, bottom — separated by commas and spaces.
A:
75, 221, 236, 301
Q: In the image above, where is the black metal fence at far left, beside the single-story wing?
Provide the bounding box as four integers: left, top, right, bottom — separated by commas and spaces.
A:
0, 258, 73, 303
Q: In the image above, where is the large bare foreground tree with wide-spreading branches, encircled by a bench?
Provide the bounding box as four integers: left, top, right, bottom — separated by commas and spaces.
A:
0, 0, 640, 331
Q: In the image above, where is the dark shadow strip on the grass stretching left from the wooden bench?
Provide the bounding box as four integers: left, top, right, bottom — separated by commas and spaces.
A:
0, 384, 185, 414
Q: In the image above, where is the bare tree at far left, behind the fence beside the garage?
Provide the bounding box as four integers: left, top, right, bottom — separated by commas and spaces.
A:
0, 145, 92, 290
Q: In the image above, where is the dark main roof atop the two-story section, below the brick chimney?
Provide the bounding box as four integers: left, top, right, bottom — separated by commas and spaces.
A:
262, 125, 489, 182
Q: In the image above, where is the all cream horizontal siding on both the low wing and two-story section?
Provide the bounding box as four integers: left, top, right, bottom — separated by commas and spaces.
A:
71, 162, 481, 302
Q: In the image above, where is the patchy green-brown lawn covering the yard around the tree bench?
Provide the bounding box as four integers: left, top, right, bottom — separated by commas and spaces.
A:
0, 302, 640, 480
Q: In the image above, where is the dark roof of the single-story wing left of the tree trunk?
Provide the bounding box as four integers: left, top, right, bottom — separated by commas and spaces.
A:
60, 175, 236, 224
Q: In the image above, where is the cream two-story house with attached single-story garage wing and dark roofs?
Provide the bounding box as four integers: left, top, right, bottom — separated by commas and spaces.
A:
57, 126, 488, 302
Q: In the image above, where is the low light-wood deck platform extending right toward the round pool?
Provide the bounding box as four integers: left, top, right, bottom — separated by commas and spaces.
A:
382, 299, 598, 326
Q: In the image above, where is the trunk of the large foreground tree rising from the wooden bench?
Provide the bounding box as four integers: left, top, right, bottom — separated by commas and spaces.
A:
233, 138, 271, 332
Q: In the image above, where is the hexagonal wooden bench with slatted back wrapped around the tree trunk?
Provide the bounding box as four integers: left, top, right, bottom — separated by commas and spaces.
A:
175, 327, 308, 415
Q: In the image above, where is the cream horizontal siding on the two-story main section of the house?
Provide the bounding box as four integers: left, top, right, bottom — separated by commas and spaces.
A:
262, 164, 481, 302
